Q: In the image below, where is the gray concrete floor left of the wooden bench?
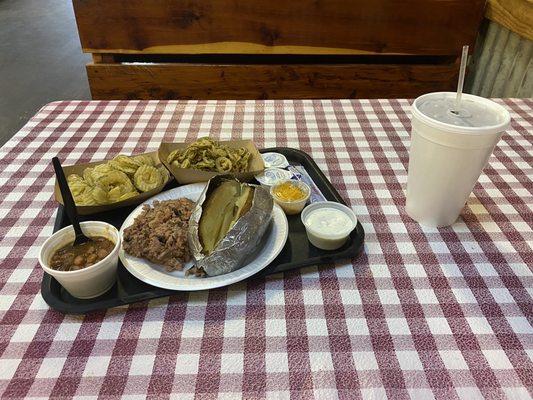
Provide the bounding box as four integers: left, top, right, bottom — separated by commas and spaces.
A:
0, 0, 90, 145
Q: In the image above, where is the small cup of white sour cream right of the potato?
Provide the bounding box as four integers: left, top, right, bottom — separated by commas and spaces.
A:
301, 201, 357, 250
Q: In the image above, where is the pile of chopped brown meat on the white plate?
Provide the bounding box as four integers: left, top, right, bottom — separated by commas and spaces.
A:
123, 198, 194, 271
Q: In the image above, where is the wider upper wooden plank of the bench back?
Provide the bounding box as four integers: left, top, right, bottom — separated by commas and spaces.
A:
73, 0, 485, 55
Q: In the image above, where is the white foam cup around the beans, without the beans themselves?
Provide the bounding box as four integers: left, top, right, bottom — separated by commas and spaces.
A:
39, 221, 120, 299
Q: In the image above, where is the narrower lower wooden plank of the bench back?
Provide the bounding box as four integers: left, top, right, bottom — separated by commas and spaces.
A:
87, 63, 457, 99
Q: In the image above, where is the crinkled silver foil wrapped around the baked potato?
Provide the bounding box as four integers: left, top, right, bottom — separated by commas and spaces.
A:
188, 175, 274, 276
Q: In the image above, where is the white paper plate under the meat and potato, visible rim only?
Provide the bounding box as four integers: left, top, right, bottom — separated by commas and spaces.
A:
119, 183, 289, 291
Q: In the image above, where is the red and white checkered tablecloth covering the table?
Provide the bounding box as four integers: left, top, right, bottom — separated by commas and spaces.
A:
0, 100, 533, 400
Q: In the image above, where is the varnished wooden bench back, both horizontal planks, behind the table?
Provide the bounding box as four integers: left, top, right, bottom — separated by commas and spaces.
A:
73, 0, 485, 99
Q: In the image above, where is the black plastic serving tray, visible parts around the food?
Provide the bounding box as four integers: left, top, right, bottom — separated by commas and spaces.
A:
41, 147, 365, 314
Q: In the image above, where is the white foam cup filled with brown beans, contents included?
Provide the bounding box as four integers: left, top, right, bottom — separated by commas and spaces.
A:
39, 221, 120, 299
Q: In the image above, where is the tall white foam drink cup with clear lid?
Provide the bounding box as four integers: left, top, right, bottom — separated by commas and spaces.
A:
405, 92, 510, 227
